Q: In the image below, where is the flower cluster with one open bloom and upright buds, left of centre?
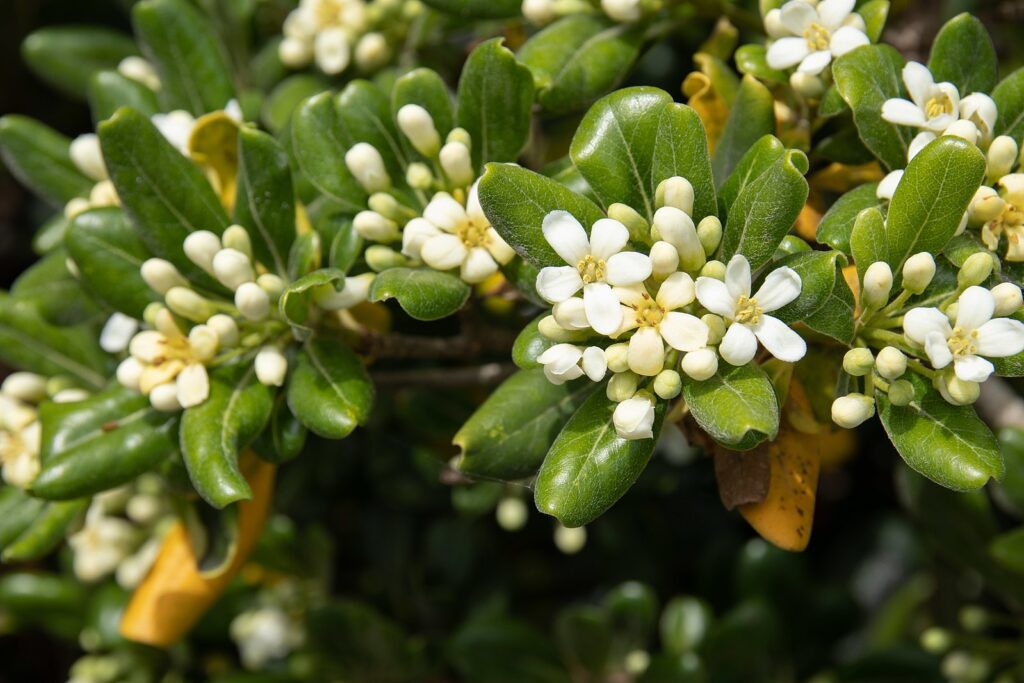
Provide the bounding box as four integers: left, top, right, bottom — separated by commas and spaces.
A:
345, 109, 515, 284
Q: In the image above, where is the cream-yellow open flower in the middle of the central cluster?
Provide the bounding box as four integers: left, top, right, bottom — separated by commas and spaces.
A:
613, 272, 709, 377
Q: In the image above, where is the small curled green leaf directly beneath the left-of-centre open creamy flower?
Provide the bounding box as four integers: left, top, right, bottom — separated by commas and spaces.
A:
370, 268, 470, 321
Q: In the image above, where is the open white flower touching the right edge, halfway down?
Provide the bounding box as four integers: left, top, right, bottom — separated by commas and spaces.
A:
903, 287, 1024, 382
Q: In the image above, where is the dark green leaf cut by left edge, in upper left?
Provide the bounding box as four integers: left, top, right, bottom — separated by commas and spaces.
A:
0, 114, 95, 210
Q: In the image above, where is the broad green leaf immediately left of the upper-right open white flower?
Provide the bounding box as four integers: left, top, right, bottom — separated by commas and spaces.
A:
833, 45, 913, 169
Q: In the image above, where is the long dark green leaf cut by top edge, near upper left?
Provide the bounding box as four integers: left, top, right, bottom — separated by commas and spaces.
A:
132, 0, 236, 116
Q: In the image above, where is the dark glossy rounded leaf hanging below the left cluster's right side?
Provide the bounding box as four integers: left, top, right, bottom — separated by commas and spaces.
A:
288, 337, 374, 438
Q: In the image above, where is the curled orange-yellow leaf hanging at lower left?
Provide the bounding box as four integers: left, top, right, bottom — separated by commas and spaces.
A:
121, 451, 275, 647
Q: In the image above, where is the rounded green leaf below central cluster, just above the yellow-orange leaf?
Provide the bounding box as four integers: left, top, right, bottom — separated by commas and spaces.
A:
683, 362, 779, 451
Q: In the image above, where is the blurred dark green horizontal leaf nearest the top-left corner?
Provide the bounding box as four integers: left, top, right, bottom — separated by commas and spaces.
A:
22, 26, 138, 99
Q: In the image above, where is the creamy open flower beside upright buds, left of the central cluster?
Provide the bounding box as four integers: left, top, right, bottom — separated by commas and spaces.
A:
401, 184, 515, 284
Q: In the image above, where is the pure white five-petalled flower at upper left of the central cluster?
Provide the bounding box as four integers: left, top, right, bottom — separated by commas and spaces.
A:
537, 211, 651, 335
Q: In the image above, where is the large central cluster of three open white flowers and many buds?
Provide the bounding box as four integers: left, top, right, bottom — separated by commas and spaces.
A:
537, 177, 807, 438
